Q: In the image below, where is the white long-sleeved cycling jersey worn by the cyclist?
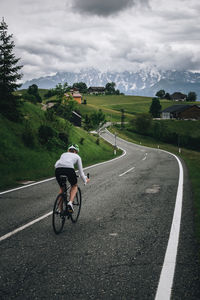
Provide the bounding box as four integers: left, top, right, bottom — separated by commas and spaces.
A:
55, 152, 87, 183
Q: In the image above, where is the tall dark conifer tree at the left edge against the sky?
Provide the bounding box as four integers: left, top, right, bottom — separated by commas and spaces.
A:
0, 19, 22, 121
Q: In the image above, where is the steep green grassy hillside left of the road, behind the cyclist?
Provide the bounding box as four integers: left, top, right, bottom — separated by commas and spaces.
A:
0, 102, 120, 190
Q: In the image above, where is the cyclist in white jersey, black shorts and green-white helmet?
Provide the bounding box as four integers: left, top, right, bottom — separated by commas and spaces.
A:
55, 144, 89, 213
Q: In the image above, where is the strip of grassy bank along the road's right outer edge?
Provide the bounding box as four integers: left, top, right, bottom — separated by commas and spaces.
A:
110, 127, 200, 248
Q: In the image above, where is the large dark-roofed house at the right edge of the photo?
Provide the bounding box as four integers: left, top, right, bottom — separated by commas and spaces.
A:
161, 104, 200, 120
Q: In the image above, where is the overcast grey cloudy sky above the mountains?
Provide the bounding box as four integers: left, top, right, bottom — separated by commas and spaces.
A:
0, 0, 200, 81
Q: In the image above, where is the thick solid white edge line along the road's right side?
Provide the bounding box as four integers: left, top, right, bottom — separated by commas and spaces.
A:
155, 151, 183, 300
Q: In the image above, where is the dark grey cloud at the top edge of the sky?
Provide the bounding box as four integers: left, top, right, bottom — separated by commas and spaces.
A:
69, 0, 148, 16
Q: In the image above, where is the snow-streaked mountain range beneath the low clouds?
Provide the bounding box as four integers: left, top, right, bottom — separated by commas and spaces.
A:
22, 68, 200, 100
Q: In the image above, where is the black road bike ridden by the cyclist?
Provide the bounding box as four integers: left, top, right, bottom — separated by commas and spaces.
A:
52, 174, 89, 234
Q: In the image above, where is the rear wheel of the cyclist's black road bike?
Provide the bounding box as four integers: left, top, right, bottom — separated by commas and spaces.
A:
52, 194, 66, 234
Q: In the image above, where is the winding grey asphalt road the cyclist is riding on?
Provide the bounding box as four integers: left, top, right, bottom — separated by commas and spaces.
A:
0, 133, 200, 300
